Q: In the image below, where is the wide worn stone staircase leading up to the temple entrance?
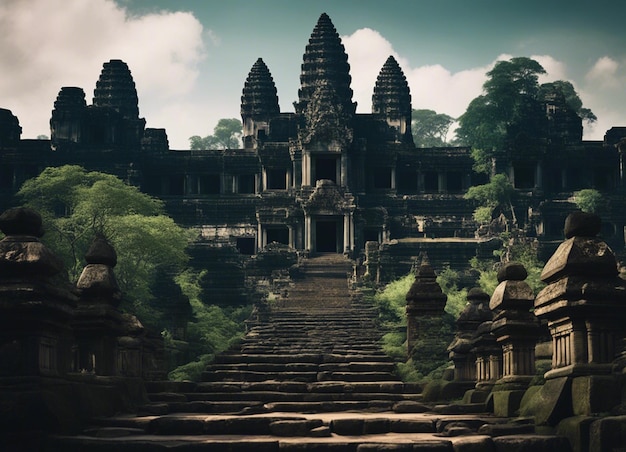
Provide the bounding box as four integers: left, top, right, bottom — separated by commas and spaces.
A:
45, 255, 569, 452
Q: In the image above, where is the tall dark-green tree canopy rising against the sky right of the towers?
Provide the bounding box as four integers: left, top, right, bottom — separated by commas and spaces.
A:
456, 57, 596, 164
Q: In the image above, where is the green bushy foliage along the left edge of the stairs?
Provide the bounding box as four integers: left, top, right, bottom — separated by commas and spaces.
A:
169, 270, 252, 381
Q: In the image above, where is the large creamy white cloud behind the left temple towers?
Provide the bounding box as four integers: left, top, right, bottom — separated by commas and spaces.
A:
0, 0, 207, 138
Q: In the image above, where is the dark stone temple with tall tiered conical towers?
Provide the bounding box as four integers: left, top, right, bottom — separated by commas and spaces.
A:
0, 14, 626, 279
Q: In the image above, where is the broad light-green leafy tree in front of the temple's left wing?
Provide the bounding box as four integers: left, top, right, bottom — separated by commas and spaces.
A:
18, 165, 191, 324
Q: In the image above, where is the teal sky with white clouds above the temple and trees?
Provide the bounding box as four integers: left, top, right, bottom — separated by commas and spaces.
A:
0, 0, 626, 149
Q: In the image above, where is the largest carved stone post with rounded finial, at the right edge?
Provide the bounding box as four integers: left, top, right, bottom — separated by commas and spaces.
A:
535, 213, 626, 422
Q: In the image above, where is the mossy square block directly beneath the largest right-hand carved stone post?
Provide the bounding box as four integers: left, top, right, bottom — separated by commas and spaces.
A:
572, 375, 621, 416
